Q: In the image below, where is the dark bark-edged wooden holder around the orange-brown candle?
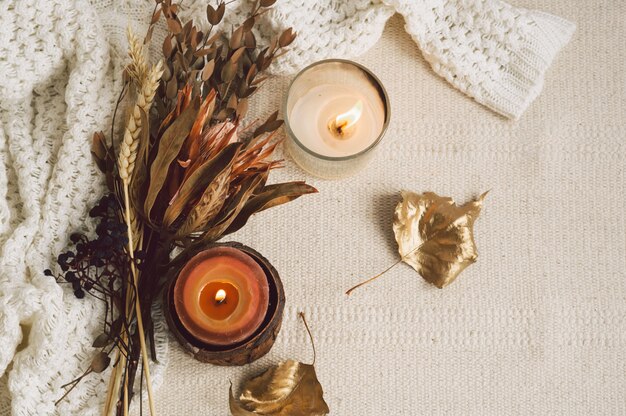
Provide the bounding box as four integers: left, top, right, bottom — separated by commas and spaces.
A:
163, 242, 285, 366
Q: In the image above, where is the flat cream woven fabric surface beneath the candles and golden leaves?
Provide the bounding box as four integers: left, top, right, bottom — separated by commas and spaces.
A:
157, 4, 626, 416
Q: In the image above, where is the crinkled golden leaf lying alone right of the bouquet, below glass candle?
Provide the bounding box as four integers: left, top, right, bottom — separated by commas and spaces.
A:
393, 192, 487, 288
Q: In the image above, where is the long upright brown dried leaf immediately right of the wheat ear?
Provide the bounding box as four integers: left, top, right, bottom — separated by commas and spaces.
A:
144, 99, 200, 218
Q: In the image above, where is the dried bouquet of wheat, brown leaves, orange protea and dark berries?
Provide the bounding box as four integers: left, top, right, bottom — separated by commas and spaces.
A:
46, 0, 316, 415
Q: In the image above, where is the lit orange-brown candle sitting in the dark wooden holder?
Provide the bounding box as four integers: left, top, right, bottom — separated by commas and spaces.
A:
174, 246, 269, 346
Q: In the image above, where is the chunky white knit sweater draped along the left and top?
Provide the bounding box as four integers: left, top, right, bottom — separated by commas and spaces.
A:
0, 0, 573, 415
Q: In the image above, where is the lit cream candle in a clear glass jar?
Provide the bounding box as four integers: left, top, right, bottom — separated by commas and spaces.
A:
285, 60, 389, 178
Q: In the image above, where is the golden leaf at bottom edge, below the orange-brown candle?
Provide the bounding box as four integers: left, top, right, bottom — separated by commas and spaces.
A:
230, 360, 329, 416
